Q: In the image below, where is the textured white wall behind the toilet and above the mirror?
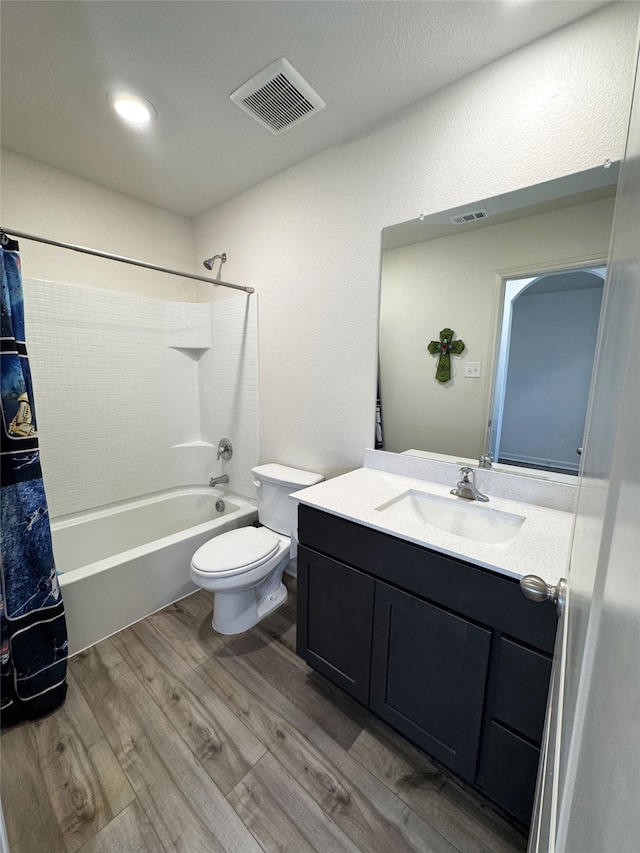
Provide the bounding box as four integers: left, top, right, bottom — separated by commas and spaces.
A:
195, 3, 638, 475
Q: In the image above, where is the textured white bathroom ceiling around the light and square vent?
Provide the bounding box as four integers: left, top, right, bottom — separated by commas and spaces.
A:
0, 0, 607, 217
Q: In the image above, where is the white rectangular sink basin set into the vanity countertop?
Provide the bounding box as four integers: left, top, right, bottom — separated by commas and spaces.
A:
375, 489, 525, 545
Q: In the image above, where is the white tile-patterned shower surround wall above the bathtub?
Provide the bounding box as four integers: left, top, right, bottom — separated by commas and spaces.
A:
24, 279, 258, 517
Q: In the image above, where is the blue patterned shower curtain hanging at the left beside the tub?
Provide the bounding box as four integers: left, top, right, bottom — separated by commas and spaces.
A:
0, 235, 67, 727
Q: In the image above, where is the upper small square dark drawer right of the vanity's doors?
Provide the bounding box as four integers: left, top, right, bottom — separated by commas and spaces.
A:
491, 637, 551, 744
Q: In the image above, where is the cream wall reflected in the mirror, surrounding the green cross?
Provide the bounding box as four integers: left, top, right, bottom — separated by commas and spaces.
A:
380, 198, 614, 461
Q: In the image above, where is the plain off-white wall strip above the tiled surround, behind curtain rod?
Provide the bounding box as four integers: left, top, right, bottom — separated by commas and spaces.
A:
0, 149, 202, 301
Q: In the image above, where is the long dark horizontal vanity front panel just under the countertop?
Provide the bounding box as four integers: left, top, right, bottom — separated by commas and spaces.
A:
298, 504, 557, 654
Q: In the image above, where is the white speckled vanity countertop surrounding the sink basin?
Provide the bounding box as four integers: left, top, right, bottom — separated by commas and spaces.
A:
292, 468, 574, 584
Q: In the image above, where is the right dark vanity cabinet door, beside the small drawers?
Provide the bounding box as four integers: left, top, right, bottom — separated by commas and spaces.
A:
370, 582, 491, 782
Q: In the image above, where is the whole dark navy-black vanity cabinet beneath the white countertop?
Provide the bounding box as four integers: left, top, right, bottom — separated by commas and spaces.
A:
297, 505, 556, 825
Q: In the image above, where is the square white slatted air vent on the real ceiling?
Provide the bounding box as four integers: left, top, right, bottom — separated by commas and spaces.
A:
229, 59, 326, 133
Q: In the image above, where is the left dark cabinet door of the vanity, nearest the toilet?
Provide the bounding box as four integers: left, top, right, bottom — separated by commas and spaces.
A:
297, 546, 375, 705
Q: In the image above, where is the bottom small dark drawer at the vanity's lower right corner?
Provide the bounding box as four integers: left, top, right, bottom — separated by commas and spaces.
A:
477, 722, 540, 826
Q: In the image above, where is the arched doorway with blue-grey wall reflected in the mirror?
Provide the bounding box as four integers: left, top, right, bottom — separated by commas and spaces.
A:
490, 266, 606, 474
